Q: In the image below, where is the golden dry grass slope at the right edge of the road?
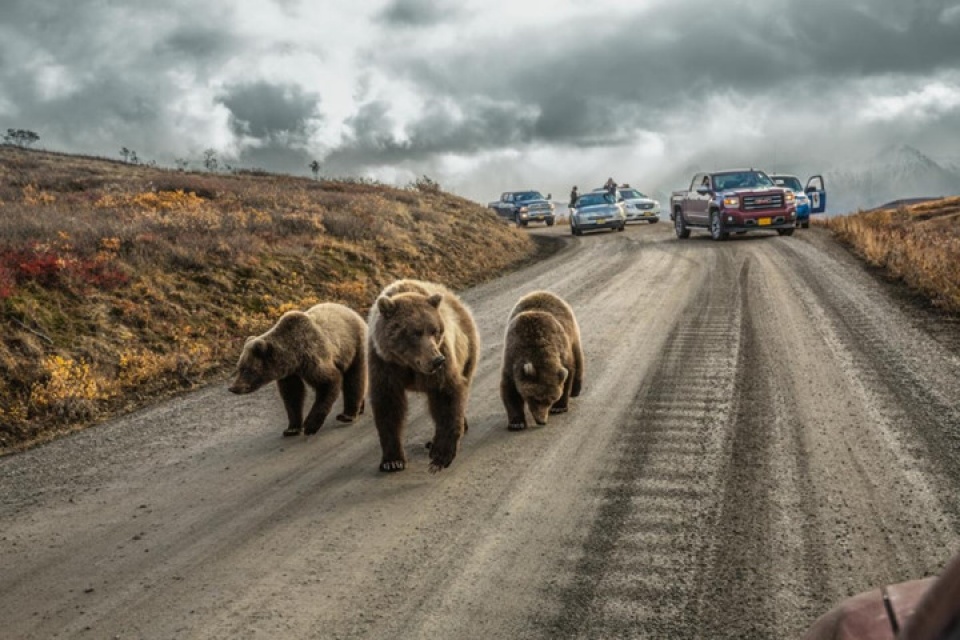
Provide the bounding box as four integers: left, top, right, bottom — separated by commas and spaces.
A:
825, 197, 960, 312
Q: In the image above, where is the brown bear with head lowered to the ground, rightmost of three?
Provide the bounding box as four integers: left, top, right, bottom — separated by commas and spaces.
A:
500, 291, 583, 431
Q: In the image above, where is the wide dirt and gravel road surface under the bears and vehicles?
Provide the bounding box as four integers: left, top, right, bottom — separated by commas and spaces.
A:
0, 223, 960, 639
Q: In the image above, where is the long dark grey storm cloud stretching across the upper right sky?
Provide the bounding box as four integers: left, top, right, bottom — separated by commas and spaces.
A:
348, 0, 960, 160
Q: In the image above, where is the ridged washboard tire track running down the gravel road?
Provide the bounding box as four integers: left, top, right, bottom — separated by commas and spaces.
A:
545, 252, 747, 638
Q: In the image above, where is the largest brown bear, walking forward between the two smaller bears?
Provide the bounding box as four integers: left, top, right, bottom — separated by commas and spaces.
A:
368, 280, 480, 473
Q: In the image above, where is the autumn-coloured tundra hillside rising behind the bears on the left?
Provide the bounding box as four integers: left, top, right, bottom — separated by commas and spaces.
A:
0, 146, 535, 453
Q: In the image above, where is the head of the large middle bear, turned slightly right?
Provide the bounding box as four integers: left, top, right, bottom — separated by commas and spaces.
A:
374, 293, 446, 375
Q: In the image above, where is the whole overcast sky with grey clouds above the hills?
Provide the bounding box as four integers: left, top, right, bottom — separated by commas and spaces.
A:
0, 0, 960, 201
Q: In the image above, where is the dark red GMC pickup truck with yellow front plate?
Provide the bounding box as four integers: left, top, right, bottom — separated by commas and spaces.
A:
670, 169, 797, 240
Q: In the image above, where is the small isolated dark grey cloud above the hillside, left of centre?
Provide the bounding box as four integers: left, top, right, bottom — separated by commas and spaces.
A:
217, 81, 319, 141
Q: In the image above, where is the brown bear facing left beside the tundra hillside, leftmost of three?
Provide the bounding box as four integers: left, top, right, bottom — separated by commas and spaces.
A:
230, 302, 367, 436
